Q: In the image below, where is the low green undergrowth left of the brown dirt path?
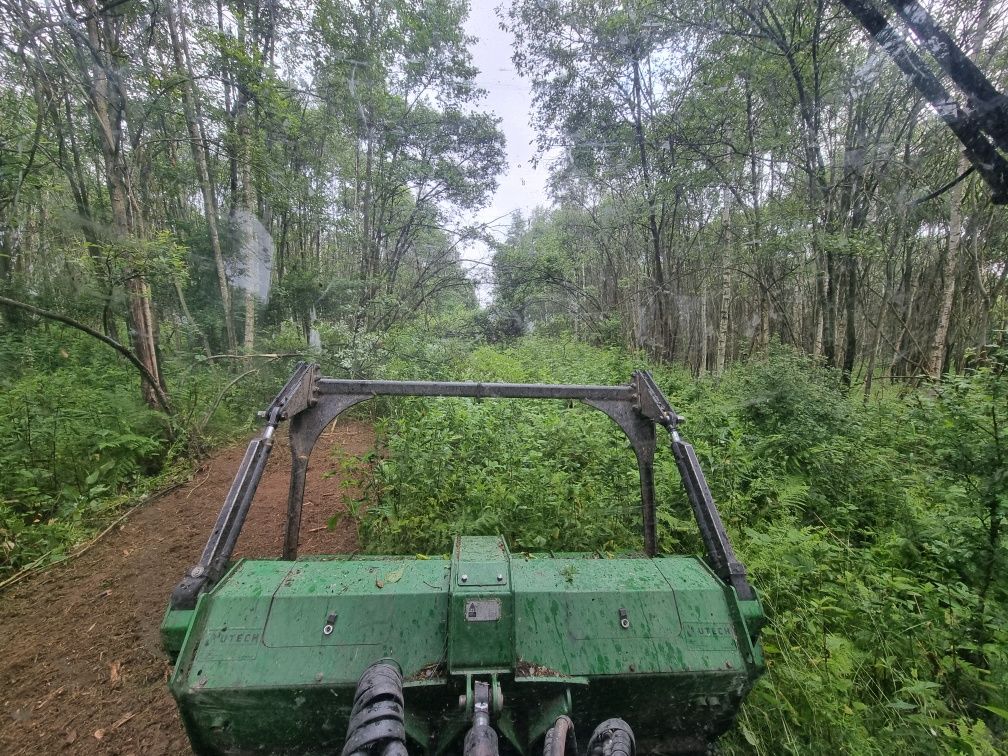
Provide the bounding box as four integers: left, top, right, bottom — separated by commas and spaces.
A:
0, 327, 306, 582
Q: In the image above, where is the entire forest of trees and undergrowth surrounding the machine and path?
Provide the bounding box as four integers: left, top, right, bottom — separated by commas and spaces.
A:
0, 0, 1008, 754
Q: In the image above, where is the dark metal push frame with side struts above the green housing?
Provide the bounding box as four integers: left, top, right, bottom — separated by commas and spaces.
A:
171, 364, 753, 609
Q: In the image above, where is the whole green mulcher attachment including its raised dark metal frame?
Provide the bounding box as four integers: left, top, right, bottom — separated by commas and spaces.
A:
161, 365, 764, 756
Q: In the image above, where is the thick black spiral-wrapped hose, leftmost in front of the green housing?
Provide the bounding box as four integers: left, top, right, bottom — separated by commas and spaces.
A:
342, 660, 406, 756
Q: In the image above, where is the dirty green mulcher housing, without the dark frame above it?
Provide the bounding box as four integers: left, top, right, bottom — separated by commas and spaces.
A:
162, 537, 762, 753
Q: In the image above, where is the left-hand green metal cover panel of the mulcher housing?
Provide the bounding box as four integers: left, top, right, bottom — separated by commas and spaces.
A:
171, 559, 449, 690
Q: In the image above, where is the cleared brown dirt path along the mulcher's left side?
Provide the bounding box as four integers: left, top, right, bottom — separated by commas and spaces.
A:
0, 420, 374, 756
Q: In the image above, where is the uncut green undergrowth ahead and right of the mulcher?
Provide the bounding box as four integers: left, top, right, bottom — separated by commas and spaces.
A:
351, 339, 1008, 754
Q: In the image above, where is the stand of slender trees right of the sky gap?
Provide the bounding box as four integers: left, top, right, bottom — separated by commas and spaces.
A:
495, 1, 1008, 379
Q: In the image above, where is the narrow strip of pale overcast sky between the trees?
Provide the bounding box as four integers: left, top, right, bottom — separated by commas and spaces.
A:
466, 0, 548, 302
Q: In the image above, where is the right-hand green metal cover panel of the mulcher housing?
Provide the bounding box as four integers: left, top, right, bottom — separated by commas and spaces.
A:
512, 557, 743, 677
